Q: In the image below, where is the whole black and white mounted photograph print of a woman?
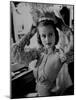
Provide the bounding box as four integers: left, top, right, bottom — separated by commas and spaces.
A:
9, 1, 74, 99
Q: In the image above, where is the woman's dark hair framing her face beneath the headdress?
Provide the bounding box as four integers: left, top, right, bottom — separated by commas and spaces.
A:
37, 20, 59, 46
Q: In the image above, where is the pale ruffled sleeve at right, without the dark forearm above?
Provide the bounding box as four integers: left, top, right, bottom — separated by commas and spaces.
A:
59, 26, 74, 63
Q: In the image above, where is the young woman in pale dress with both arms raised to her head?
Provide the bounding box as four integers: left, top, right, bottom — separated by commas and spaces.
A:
11, 11, 73, 96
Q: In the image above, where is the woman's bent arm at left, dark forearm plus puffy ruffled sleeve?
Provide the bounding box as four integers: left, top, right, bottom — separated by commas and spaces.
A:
11, 26, 40, 64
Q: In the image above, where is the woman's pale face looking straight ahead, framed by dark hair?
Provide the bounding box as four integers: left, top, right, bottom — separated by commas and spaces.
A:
38, 25, 55, 48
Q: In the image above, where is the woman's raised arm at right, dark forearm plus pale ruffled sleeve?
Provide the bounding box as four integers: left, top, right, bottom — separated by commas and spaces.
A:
56, 16, 74, 63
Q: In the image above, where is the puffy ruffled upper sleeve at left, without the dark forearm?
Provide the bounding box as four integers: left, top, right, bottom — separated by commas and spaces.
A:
11, 44, 40, 64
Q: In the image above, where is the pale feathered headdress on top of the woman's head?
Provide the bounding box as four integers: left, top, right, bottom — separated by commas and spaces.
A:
31, 4, 63, 24
